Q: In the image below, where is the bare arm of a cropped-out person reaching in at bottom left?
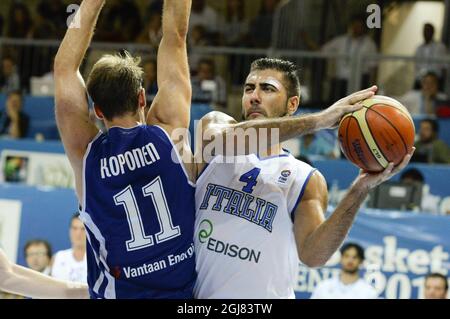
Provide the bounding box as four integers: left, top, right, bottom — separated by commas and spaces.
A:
0, 249, 89, 299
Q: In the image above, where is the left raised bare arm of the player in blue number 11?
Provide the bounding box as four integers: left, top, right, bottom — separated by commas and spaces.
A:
54, 0, 104, 200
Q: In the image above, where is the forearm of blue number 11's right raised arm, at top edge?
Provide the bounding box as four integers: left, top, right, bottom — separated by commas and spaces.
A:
162, 0, 192, 43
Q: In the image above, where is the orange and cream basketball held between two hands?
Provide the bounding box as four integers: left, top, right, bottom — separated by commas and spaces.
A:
339, 95, 415, 172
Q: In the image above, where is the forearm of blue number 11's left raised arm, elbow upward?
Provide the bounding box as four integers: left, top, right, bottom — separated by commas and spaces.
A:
54, 0, 105, 76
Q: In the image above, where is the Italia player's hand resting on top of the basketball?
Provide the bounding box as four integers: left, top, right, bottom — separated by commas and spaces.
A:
317, 86, 378, 130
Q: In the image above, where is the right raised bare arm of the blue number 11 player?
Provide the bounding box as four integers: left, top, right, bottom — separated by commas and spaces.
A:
147, 0, 192, 135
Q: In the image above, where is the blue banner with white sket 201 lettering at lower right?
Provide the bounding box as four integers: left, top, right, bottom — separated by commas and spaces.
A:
296, 210, 450, 299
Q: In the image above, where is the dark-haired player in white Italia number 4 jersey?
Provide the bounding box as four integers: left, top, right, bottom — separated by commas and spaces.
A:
194, 59, 411, 299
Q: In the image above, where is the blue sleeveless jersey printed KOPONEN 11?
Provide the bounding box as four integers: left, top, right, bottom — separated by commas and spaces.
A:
80, 126, 196, 299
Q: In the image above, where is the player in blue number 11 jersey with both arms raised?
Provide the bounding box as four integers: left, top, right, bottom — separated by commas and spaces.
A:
54, 0, 196, 299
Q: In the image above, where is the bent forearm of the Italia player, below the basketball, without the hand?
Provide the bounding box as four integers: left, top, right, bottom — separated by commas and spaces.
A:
300, 184, 368, 267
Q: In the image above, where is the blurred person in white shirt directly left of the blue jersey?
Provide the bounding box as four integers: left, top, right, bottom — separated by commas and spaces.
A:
52, 213, 87, 283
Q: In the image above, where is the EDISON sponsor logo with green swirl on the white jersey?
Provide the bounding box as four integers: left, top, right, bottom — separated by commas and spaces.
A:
198, 219, 261, 264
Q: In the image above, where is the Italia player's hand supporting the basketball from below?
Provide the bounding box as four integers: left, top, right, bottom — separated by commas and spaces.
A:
354, 147, 416, 191
